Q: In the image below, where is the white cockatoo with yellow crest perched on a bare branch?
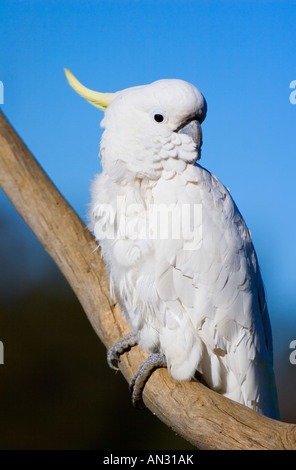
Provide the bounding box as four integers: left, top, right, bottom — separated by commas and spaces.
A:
65, 70, 279, 419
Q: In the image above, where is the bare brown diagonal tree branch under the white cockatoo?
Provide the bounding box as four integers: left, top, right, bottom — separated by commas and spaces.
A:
0, 108, 296, 449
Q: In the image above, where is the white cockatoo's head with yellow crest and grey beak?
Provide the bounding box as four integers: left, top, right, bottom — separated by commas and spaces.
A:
65, 70, 207, 178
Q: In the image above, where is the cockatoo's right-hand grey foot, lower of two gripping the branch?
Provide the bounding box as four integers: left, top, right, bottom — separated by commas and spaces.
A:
129, 353, 167, 408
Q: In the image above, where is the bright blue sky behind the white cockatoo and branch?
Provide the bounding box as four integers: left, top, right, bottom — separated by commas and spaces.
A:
0, 0, 296, 416
